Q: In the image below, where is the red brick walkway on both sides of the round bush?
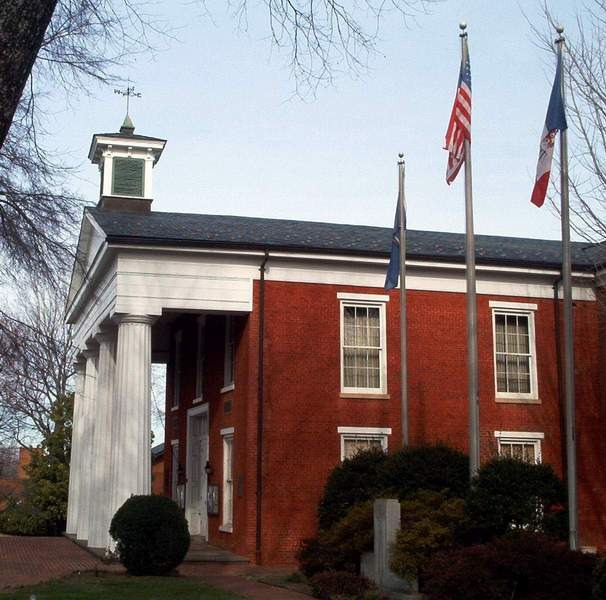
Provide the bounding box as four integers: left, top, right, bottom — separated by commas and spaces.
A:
0, 536, 309, 600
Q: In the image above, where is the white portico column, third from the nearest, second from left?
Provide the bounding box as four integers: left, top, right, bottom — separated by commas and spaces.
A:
76, 349, 97, 540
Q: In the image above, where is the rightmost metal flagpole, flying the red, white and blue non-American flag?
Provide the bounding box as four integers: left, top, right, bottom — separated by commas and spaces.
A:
556, 27, 579, 550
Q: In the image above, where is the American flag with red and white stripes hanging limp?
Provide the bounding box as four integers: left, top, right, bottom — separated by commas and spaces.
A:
444, 40, 471, 185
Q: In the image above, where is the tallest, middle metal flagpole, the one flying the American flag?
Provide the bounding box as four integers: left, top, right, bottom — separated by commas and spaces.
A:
459, 22, 480, 477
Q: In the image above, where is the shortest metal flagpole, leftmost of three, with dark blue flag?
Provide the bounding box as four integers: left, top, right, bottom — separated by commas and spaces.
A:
398, 153, 409, 448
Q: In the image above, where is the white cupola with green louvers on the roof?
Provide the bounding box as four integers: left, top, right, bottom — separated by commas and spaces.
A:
88, 113, 166, 212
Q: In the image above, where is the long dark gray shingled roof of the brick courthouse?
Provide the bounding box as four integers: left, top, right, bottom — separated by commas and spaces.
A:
87, 208, 606, 271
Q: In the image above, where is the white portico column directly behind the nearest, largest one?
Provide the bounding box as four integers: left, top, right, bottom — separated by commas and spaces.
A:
88, 331, 116, 549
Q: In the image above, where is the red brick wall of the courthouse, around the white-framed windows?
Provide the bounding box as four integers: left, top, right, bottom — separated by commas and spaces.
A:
167, 281, 606, 564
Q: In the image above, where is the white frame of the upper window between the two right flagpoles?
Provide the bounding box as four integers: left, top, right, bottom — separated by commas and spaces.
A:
489, 300, 539, 403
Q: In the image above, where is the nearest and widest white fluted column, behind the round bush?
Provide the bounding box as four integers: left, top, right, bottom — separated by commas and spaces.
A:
110, 315, 154, 520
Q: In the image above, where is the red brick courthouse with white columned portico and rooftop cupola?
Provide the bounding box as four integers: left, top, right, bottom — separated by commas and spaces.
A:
68, 123, 606, 564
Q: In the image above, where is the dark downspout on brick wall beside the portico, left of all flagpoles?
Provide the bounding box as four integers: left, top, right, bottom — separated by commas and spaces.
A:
255, 250, 269, 565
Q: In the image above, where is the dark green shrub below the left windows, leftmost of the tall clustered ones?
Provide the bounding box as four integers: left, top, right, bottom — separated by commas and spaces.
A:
318, 449, 387, 529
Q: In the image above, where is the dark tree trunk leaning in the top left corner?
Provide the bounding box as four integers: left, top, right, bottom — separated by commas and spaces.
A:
0, 0, 57, 148
